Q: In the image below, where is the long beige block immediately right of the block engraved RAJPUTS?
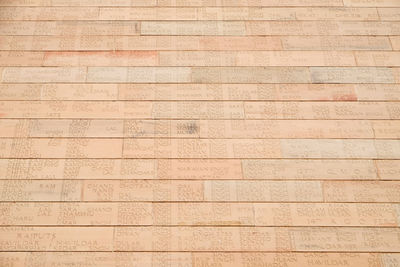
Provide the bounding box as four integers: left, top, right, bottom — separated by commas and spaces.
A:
114, 227, 291, 251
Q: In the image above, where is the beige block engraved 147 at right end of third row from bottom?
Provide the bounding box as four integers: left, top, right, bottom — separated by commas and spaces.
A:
253, 203, 398, 227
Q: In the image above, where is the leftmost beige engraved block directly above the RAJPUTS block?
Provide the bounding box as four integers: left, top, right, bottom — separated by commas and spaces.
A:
0, 205, 153, 226
